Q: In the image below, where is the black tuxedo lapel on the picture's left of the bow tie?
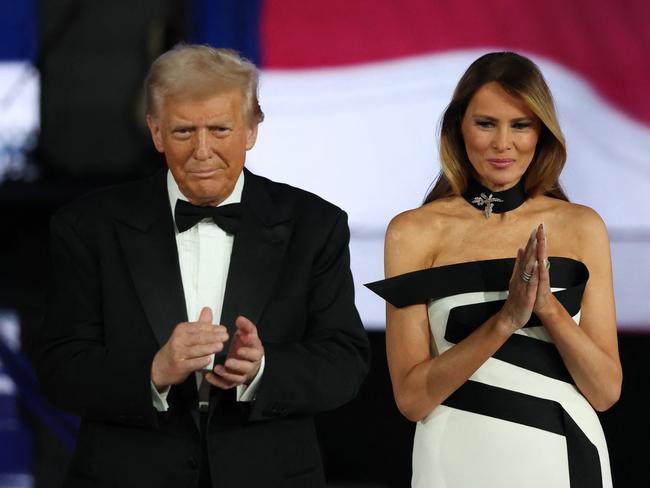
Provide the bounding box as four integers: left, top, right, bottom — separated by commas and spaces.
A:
111, 171, 187, 347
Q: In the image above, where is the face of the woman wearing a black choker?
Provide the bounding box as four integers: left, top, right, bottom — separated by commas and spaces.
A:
461, 82, 541, 191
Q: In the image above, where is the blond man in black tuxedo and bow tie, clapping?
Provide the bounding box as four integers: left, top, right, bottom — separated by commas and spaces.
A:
38, 46, 369, 488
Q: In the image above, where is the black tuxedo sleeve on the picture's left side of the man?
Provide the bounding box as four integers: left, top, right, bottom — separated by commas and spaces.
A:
37, 213, 156, 425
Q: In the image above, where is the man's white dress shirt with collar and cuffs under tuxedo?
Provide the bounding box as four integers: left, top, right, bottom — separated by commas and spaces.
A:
151, 171, 264, 412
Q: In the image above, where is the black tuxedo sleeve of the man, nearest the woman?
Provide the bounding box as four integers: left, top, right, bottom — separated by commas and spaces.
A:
251, 211, 370, 420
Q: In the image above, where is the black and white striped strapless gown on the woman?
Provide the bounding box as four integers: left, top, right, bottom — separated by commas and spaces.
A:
368, 257, 612, 488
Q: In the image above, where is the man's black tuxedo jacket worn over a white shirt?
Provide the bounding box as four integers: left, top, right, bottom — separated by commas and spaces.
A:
37, 166, 369, 488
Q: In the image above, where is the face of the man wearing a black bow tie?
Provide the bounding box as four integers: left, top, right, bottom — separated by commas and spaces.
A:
147, 90, 257, 205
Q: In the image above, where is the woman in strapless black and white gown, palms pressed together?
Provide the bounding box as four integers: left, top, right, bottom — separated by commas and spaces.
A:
368, 53, 622, 488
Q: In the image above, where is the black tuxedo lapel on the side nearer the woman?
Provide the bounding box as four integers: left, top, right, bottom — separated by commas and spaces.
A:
221, 169, 293, 356
